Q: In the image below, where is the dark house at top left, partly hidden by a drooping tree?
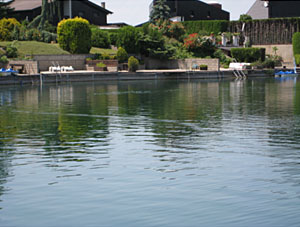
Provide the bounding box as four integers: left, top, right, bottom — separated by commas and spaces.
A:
9, 0, 112, 25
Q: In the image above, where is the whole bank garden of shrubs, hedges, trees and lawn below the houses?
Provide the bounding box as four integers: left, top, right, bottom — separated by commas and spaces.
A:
0, 0, 300, 71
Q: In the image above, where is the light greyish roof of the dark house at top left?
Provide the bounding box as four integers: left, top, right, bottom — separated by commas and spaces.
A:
10, 0, 112, 14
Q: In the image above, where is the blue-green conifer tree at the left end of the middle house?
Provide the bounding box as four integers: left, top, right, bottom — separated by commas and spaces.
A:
150, 0, 171, 23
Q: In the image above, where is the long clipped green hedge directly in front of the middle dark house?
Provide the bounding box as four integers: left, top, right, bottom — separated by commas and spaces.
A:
183, 20, 229, 34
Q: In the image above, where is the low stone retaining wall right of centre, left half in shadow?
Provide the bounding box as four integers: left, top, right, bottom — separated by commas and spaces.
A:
145, 58, 220, 71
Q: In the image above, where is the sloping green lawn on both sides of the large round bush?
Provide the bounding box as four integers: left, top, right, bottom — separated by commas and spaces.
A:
0, 41, 117, 58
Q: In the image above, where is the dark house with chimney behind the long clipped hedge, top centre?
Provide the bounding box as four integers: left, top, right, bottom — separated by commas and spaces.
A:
150, 0, 230, 21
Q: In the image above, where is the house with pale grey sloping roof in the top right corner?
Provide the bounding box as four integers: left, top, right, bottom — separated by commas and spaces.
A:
247, 0, 300, 19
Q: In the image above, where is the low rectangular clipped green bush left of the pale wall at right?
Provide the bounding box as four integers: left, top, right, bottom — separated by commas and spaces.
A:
231, 47, 266, 63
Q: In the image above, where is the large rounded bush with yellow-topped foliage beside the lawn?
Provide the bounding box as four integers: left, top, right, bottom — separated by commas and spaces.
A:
57, 17, 92, 54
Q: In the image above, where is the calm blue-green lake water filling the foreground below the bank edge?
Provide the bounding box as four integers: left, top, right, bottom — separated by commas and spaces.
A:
0, 78, 300, 227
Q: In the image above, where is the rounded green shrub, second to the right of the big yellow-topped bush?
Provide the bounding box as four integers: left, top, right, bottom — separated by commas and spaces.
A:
117, 26, 140, 53
